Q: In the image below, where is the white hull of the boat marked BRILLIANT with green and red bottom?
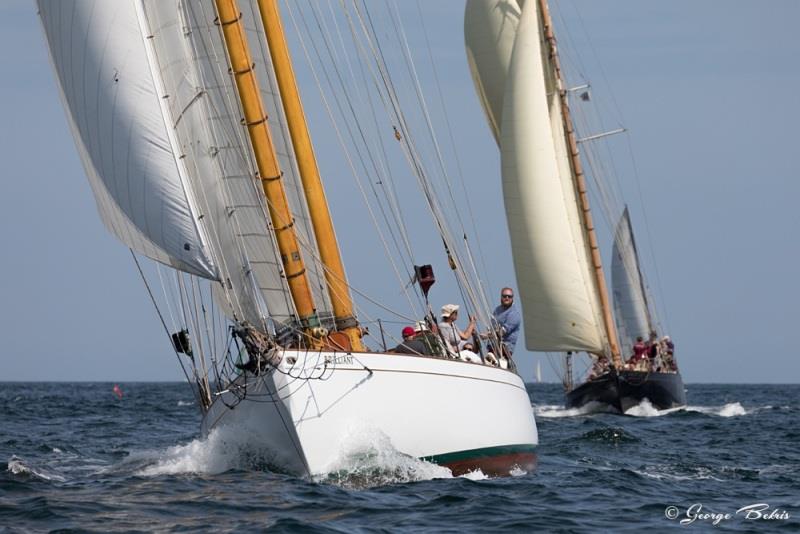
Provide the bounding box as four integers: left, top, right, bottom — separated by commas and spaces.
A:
202, 350, 538, 475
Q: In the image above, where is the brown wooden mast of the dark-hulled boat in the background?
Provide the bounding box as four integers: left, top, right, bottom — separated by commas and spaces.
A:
539, 0, 622, 368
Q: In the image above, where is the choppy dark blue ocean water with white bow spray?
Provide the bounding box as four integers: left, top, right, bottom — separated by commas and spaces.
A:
0, 383, 800, 532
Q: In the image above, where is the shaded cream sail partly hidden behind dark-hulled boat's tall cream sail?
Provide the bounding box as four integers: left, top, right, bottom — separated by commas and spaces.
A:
464, 0, 523, 144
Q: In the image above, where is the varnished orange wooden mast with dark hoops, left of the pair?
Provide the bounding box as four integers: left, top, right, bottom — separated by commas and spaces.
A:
215, 0, 319, 329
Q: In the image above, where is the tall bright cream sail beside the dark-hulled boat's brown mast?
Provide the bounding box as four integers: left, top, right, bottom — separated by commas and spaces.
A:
500, 2, 607, 353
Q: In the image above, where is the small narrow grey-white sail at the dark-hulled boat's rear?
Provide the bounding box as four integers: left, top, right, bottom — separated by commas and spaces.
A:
611, 207, 651, 354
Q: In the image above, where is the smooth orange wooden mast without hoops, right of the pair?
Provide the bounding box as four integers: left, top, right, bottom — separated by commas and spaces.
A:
258, 0, 364, 351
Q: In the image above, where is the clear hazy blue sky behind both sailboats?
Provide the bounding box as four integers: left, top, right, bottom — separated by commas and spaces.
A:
0, 0, 800, 382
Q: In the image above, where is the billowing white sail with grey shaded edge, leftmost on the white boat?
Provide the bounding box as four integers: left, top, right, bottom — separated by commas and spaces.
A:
39, 0, 217, 278
